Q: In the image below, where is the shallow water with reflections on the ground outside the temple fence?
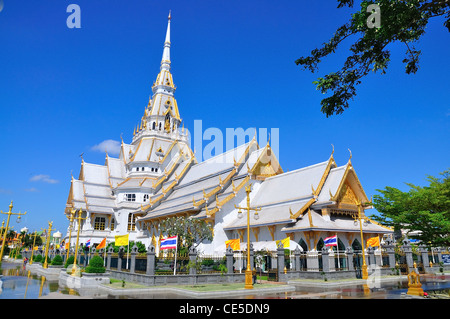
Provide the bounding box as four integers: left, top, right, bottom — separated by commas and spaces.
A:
0, 262, 450, 299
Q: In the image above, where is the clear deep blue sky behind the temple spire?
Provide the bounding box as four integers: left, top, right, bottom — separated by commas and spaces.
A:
0, 0, 450, 234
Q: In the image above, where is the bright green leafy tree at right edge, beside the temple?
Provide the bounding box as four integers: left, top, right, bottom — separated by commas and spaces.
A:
371, 170, 450, 247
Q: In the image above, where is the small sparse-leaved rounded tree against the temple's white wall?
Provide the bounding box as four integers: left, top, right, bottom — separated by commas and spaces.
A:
159, 217, 213, 248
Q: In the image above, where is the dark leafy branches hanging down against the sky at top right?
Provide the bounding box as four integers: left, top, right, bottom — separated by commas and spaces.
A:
295, 0, 450, 117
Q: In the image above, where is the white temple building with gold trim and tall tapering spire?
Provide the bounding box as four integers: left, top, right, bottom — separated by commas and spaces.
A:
65, 15, 393, 254
